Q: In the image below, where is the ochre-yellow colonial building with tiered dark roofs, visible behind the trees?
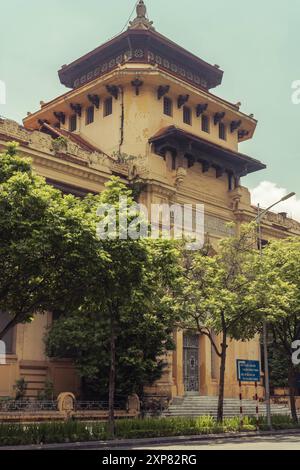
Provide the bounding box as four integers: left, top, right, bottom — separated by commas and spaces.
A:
0, 0, 300, 398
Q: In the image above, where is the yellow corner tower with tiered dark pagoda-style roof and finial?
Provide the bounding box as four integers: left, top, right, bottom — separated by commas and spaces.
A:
24, 0, 264, 193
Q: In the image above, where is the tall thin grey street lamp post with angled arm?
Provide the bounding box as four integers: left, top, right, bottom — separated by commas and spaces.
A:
255, 192, 296, 429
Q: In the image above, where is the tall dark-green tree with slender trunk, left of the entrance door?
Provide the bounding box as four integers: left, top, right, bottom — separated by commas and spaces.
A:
48, 178, 182, 436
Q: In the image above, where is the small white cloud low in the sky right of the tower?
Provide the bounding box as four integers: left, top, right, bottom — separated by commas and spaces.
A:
250, 181, 300, 222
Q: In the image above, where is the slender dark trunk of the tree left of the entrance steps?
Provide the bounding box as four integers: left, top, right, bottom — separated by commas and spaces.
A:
108, 318, 116, 439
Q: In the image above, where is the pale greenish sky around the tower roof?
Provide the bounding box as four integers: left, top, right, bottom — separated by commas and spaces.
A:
0, 0, 300, 220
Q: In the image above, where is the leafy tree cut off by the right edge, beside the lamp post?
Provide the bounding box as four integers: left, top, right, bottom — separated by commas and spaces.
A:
262, 238, 300, 422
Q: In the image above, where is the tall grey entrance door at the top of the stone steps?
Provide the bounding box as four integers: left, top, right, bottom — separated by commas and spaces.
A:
183, 334, 199, 393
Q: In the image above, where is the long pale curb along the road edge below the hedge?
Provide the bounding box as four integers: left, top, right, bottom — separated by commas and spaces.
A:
0, 429, 300, 451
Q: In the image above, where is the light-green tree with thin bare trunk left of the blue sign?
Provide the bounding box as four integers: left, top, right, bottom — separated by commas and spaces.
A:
180, 225, 286, 421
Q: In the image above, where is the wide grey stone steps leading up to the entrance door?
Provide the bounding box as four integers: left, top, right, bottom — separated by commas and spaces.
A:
164, 395, 290, 418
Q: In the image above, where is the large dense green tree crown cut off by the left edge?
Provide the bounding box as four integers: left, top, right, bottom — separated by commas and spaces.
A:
0, 143, 105, 339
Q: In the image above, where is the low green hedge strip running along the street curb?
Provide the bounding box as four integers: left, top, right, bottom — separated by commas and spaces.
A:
0, 416, 256, 446
